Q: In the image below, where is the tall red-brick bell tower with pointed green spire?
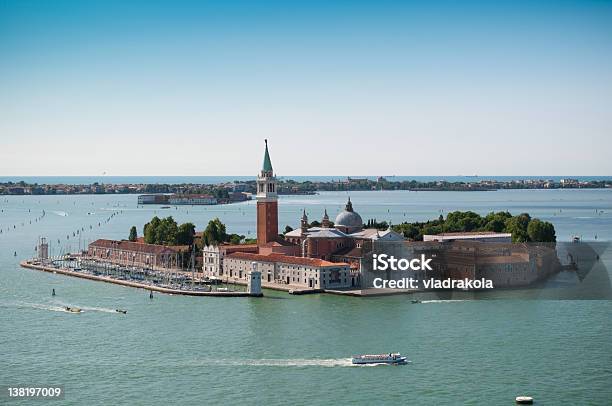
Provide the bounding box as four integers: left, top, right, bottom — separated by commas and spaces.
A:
257, 140, 278, 245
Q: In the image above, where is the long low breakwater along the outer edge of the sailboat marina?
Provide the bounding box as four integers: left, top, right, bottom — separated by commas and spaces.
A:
19, 261, 263, 297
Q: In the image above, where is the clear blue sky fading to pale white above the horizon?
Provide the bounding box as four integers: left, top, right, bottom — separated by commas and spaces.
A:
0, 0, 612, 176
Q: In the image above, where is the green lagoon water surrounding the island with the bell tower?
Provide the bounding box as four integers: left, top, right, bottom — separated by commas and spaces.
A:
0, 190, 612, 405
